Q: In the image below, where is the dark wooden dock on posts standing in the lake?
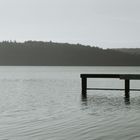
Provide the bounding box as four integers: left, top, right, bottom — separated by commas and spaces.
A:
80, 74, 140, 98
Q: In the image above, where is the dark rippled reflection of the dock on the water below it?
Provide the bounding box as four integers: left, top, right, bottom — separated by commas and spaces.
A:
81, 91, 140, 113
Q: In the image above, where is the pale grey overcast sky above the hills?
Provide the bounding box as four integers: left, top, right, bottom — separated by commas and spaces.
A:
0, 0, 140, 48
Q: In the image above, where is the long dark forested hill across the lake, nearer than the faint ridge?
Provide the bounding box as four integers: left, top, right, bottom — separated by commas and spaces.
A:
0, 41, 140, 66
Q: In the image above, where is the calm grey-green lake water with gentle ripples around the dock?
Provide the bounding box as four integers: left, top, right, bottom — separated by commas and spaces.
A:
0, 67, 140, 140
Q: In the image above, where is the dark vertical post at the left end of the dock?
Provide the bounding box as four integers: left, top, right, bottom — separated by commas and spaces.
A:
82, 77, 87, 98
